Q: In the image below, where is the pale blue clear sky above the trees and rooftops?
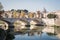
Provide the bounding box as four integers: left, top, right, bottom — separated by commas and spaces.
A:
0, 0, 60, 11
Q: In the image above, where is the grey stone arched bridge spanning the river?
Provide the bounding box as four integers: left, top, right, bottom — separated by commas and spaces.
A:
0, 18, 44, 28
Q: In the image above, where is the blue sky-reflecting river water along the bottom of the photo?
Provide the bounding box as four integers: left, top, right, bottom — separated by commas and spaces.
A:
14, 33, 60, 40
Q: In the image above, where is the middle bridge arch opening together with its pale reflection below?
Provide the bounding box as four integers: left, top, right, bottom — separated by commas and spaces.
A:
13, 19, 28, 31
